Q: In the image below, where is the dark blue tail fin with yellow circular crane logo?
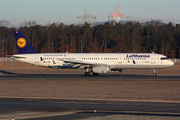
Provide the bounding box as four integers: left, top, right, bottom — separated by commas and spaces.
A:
14, 31, 38, 54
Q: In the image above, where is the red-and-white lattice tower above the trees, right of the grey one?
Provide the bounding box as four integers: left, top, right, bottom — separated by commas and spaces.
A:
108, 4, 128, 24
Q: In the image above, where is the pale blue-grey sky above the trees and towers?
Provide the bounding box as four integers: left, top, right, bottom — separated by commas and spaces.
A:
0, 0, 180, 25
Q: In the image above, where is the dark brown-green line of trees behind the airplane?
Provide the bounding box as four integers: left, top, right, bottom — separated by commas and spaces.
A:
0, 20, 180, 58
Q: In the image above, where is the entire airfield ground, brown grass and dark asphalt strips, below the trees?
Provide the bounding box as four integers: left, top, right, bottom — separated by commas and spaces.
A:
0, 64, 180, 120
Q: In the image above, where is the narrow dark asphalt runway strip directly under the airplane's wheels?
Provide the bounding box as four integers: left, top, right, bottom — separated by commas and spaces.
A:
0, 74, 180, 81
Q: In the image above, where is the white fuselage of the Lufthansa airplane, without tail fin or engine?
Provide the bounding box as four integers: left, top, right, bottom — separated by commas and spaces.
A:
12, 53, 174, 69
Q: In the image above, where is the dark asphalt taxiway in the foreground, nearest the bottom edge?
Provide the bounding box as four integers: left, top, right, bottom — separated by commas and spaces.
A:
0, 99, 180, 120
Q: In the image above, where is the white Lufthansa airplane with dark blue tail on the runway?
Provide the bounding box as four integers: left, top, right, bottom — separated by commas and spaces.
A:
11, 31, 174, 76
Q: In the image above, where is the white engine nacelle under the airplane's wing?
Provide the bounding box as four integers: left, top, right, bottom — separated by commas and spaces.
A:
93, 66, 110, 73
